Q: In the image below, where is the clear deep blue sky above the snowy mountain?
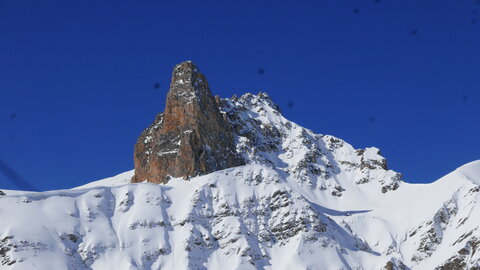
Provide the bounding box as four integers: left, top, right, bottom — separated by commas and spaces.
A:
0, 0, 480, 190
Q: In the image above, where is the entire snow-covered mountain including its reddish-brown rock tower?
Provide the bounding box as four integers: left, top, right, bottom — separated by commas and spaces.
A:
0, 62, 480, 270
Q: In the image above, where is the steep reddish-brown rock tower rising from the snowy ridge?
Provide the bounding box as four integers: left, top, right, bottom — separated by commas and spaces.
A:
132, 61, 245, 183
